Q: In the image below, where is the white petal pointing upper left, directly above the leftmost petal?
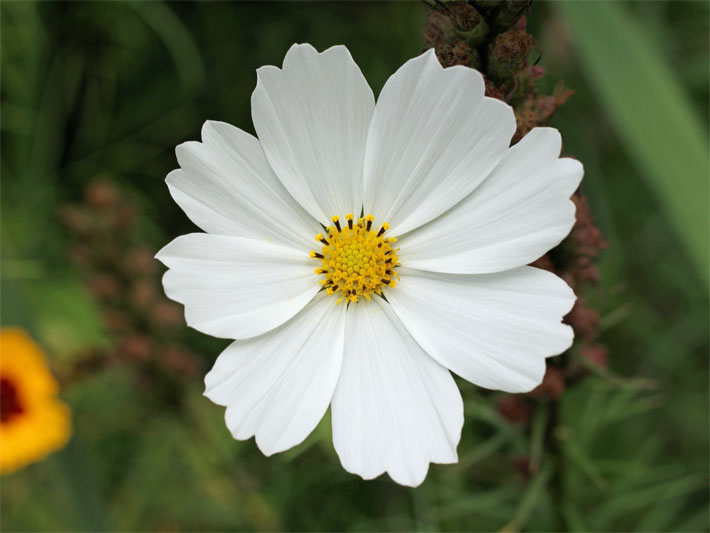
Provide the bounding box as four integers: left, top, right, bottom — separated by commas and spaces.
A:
166, 121, 321, 251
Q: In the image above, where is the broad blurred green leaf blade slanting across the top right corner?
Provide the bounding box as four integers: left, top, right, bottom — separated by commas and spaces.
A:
555, 2, 708, 283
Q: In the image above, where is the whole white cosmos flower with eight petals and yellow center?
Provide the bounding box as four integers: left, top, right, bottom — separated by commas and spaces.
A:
157, 44, 583, 486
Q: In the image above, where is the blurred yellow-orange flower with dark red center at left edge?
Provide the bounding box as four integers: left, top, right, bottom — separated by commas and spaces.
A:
0, 328, 71, 474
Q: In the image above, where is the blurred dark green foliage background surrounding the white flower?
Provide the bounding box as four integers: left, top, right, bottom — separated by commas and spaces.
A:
0, 1, 709, 531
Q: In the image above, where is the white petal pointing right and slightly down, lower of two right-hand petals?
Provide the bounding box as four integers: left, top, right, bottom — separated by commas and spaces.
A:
387, 267, 575, 392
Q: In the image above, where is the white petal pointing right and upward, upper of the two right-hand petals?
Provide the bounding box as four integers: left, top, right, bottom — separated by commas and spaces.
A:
398, 128, 584, 274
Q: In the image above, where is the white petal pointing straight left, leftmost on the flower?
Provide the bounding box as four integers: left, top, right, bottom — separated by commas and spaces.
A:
156, 233, 321, 339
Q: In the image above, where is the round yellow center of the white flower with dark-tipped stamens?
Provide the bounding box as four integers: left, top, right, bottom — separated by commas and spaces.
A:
311, 213, 399, 303
